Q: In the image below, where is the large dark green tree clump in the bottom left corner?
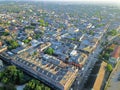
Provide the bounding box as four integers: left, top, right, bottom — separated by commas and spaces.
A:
0, 66, 24, 90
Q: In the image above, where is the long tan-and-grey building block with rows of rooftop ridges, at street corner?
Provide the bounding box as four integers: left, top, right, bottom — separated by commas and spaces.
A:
11, 52, 78, 90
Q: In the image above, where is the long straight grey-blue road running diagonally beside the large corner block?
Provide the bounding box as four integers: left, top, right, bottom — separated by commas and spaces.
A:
71, 23, 110, 90
